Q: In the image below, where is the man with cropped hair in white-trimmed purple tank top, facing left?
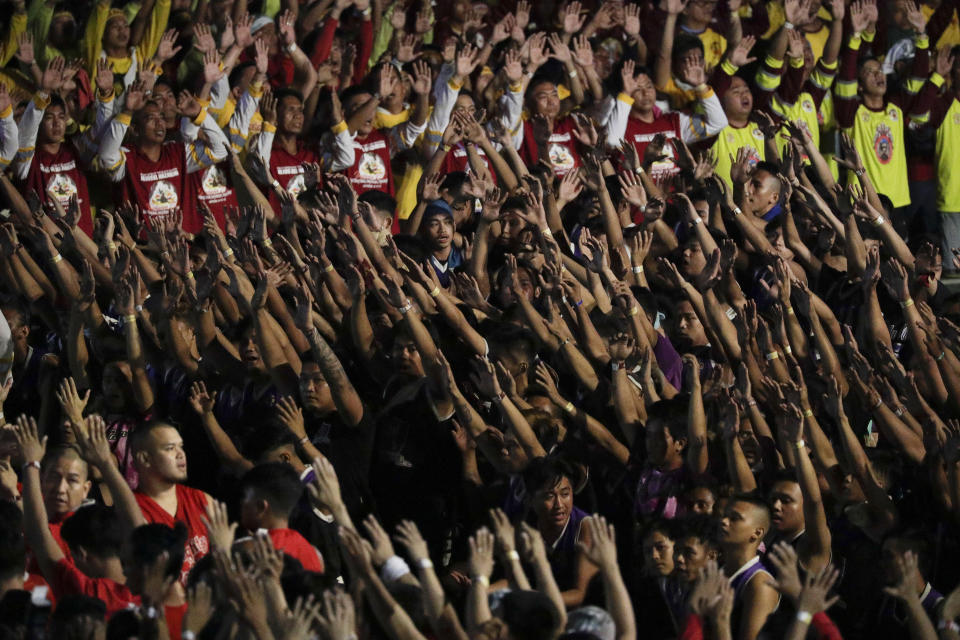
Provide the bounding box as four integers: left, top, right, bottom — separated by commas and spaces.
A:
720, 495, 780, 640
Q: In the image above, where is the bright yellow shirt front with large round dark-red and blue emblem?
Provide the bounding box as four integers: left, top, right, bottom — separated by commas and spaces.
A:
849, 103, 910, 207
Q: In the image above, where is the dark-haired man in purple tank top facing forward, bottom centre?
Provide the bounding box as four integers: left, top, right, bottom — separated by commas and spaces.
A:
523, 457, 597, 607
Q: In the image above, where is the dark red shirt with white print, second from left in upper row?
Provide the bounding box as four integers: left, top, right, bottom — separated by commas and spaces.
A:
123, 142, 203, 233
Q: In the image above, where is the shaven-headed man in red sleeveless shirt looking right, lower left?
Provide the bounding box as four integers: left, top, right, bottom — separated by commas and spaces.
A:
130, 422, 211, 584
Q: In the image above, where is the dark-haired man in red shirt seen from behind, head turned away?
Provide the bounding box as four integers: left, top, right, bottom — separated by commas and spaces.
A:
240, 462, 323, 573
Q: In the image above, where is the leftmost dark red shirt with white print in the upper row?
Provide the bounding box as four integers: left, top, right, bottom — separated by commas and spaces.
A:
24, 142, 93, 236
